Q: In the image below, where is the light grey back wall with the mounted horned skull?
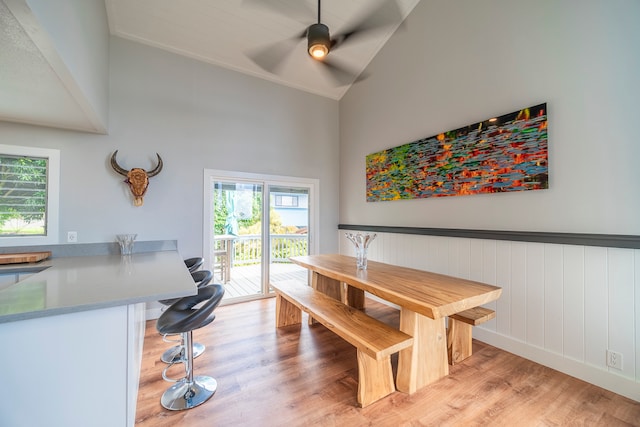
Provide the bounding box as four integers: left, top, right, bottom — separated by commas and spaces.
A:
0, 38, 338, 258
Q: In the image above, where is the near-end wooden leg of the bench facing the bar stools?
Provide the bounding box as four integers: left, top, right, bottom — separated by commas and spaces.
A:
358, 350, 396, 408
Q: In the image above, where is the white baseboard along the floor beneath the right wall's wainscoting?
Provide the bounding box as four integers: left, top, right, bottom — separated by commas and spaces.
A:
473, 326, 640, 402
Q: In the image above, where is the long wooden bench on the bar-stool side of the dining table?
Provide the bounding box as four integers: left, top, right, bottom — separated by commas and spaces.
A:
271, 280, 413, 407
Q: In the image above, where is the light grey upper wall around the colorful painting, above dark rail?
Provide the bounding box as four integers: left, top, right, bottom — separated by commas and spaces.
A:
340, 0, 640, 235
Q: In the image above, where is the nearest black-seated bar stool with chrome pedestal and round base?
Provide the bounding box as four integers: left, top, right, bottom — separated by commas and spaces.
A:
156, 284, 224, 411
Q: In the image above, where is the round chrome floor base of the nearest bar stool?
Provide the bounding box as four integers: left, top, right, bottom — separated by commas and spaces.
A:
160, 375, 218, 411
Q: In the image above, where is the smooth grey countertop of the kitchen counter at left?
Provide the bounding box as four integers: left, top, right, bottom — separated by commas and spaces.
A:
0, 251, 196, 323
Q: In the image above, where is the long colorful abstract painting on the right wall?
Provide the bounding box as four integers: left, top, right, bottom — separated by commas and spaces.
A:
366, 104, 549, 202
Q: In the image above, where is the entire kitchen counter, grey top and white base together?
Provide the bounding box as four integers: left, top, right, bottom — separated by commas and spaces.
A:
0, 251, 196, 427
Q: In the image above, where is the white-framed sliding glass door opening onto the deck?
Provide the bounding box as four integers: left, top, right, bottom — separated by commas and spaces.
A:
203, 170, 317, 302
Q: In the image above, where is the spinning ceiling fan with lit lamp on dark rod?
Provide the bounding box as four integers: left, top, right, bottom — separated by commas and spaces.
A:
247, 0, 402, 86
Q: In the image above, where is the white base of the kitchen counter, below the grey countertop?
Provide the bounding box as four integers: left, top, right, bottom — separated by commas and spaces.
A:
0, 303, 144, 427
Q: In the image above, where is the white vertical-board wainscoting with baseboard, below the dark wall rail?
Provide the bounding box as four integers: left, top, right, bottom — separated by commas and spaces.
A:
339, 229, 640, 401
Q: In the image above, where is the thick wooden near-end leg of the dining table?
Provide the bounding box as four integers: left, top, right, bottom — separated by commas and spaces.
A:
396, 308, 449, 394
